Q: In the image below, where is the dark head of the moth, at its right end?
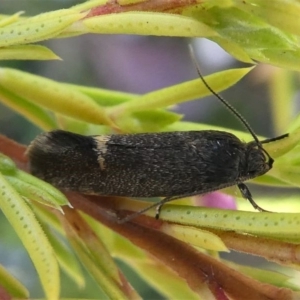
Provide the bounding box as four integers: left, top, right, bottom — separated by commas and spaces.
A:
242, 142, 274, 178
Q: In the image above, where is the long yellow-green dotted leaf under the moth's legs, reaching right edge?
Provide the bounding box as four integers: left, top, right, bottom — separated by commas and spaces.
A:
157, 204, 300, 238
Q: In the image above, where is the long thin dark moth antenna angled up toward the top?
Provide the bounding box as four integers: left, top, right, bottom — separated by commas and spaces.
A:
189, 44, 274, 165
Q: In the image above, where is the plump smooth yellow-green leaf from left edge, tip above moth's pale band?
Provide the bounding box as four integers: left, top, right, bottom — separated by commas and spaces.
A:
0, 68, 113, 125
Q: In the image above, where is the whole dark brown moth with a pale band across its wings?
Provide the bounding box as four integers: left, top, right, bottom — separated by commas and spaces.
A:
27, 47, 287, 220
